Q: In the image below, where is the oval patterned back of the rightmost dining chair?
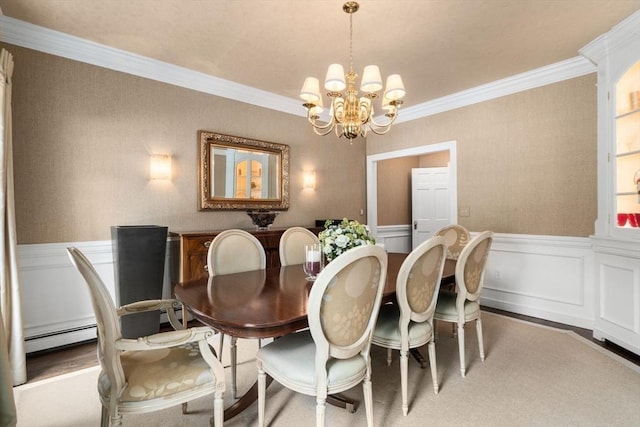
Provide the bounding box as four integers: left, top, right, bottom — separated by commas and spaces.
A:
456, 231, 493, 301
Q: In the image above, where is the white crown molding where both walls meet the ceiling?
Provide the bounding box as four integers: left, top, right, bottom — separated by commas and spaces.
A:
0, 16, 596, 124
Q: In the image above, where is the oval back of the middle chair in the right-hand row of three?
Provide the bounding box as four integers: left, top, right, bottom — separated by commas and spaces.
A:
396, 236, 447, 324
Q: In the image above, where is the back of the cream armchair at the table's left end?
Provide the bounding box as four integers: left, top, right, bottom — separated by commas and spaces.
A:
67, 247, 125, 390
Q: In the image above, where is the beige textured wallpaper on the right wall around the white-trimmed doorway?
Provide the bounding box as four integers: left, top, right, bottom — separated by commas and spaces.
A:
367, 74, 597, 236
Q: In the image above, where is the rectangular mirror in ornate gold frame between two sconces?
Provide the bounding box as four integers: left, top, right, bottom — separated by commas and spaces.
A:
198, 131, 289, 210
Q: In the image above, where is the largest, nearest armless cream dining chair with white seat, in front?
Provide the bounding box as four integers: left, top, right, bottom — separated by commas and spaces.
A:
257, 245, 387, 427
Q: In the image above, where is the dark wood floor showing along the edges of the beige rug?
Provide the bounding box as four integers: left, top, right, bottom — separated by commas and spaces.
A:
27, 307, 640, 383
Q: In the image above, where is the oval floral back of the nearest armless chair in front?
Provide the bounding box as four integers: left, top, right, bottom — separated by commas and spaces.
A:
307, 245, 387, 362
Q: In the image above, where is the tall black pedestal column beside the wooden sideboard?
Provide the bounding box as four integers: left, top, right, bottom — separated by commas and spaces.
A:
111, 225, 167, 338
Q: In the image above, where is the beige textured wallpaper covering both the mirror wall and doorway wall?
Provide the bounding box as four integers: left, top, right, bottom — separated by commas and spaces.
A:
5, 45, 596, 244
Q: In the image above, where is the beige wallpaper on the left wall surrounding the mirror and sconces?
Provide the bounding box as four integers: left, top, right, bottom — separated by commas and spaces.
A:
3, 45, 366, 244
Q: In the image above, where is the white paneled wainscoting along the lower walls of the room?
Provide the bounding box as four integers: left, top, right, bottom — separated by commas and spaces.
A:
18, 234, 595, 353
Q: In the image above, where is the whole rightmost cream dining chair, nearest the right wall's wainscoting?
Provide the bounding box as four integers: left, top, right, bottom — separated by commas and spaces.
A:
433, 231, 493, 377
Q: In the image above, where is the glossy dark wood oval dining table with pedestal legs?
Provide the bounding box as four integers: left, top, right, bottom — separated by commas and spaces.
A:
174, 252, 455, 420
